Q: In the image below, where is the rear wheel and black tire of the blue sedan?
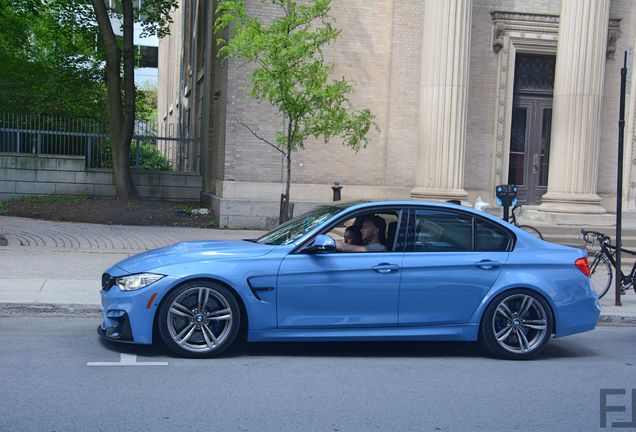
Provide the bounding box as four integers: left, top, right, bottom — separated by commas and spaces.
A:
479, 289, 554, 360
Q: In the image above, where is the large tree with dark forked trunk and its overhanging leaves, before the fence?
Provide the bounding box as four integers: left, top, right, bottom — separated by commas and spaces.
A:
87, 0, 178, 200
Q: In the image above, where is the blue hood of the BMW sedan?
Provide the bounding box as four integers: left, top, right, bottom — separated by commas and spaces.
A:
112, 240, 274, 273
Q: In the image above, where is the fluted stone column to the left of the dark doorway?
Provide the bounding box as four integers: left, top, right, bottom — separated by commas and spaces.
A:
411, 0, 472, 200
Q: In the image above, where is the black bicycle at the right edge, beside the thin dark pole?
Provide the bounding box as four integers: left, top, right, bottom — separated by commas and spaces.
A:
581, 230, 636, 298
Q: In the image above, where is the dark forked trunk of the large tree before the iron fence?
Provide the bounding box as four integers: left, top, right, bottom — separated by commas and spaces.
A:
91, 0, 139, 200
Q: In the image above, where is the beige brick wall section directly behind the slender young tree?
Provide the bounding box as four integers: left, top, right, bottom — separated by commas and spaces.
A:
220, 0, 393, 184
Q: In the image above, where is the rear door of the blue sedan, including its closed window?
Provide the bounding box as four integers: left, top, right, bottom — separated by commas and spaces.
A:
399, 208, 512, 326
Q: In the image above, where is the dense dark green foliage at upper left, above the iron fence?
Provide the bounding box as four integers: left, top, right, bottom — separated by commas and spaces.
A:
0, 0, 106, 117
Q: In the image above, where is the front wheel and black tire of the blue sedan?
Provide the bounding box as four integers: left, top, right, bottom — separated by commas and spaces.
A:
158, 281, 241, 358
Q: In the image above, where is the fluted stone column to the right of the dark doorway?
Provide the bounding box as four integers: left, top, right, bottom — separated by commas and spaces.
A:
539, 0, 610, 214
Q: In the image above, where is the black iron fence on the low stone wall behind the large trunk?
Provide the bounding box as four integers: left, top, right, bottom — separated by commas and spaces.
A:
0, 113, 199, 172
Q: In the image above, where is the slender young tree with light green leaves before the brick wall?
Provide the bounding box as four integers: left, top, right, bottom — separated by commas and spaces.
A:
215, 0, 374, 222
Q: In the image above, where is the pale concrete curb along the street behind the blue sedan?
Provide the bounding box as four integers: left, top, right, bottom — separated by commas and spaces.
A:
0, 303, 636, 327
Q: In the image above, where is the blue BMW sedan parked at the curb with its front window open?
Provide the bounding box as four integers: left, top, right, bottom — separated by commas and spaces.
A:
98, 201, 600, 359
